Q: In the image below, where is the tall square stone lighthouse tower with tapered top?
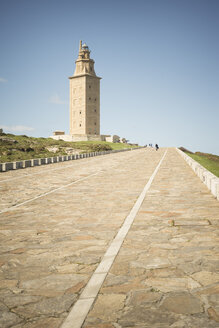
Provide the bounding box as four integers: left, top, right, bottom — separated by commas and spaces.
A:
69, 41, 101, 140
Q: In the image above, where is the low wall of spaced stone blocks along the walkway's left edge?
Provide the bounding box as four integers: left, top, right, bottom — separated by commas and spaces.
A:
0, 147, 140, 172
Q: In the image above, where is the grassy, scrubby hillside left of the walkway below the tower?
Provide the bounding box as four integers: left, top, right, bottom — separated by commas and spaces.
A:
0, 133, 136, 163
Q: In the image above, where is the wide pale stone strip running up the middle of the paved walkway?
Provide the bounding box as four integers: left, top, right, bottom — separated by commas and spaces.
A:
61, 150, 167, 328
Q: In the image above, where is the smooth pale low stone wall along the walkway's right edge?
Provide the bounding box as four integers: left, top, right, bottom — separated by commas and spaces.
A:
176, 148, 219, 200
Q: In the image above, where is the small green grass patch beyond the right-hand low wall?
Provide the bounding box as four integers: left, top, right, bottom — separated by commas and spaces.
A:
186, 152, 219, 177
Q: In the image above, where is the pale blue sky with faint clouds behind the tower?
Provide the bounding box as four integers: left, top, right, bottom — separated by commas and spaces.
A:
0, 0, 219, 155
